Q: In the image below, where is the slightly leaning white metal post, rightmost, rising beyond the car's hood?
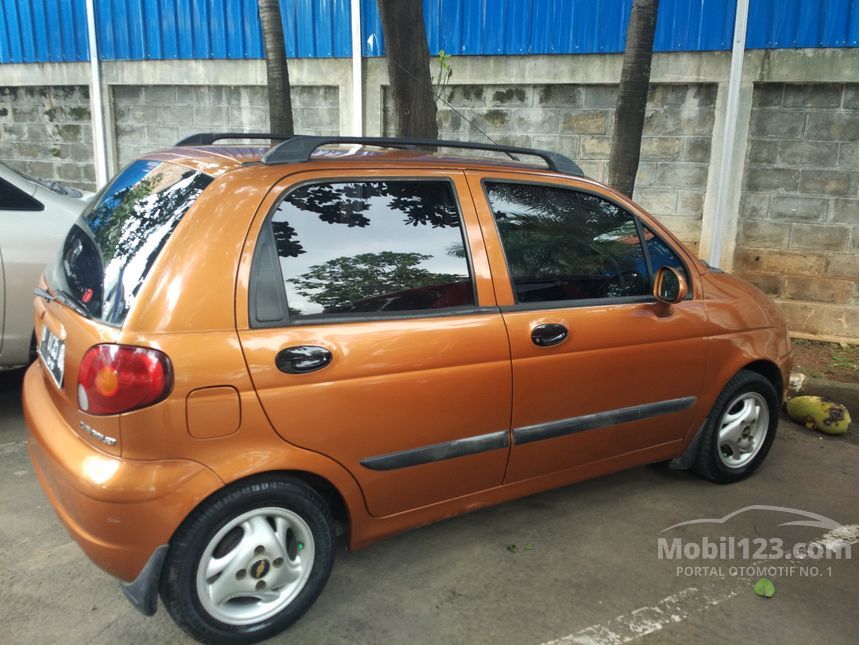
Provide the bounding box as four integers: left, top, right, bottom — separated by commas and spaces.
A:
708, 0, 749, 267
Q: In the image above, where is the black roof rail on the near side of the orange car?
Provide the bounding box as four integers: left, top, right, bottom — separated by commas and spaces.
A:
261, 135, 584, 177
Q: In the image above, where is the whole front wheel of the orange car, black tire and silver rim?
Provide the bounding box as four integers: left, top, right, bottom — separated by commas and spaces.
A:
693, 370, 779, 484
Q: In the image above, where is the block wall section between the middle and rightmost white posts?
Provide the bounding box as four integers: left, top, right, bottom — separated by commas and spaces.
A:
383, 83, 717, 255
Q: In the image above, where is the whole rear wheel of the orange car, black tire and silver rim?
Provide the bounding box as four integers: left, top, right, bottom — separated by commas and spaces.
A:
160, 477, 335, 643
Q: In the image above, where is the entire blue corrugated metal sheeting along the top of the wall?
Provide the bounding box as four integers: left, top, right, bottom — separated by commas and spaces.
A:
0, 0, 858, 63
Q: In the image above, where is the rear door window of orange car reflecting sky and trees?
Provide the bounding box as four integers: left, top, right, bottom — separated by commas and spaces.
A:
271, 180, 475, 317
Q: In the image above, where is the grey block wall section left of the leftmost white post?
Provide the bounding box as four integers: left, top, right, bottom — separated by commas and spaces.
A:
0, 85, 95, 189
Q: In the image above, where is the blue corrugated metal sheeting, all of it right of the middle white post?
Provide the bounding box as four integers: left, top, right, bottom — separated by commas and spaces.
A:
362, 0, 858, 56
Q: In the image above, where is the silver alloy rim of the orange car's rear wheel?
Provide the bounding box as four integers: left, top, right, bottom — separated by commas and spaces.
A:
197, 507, 314, 625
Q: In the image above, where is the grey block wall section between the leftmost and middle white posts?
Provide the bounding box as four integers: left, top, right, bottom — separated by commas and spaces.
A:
111, 85, 340, 166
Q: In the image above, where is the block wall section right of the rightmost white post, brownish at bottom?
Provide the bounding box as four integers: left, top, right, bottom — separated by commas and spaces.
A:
734, 83, 858, 337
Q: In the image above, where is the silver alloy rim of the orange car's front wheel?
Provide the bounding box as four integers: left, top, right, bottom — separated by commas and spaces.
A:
718, 392, 770, 468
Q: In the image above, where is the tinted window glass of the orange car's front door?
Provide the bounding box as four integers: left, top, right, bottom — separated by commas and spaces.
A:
486, 182, 649, 302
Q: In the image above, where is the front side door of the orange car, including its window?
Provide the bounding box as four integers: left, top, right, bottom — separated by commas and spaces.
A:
467, 173, 706, 482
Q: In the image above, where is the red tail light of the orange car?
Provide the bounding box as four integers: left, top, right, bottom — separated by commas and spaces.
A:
78, 344, 173, 415
